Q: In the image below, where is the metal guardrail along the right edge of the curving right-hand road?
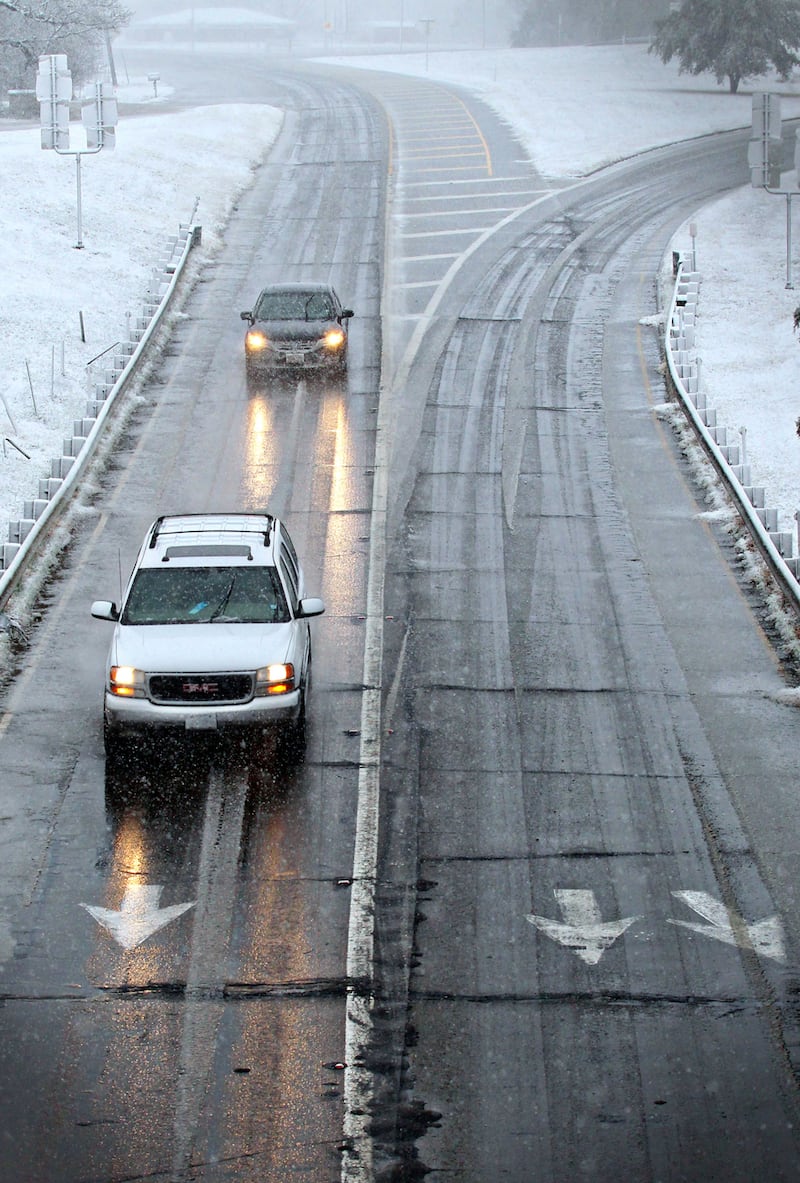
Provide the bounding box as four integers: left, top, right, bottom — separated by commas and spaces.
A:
664, 260, 800, 614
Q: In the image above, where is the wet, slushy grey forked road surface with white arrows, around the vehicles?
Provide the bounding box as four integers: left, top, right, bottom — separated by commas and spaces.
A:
0, 53, 800, 1183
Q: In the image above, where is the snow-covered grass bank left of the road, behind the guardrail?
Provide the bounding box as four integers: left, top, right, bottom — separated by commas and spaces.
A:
0, 95, 282, 539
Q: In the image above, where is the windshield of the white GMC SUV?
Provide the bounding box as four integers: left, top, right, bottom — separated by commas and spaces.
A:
121, 567, 290, 625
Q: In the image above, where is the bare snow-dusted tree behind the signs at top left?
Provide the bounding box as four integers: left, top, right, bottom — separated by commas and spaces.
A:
0, 0, 130, 90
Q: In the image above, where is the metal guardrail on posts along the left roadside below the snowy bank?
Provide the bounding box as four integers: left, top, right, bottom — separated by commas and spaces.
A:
0, 221, 202, 605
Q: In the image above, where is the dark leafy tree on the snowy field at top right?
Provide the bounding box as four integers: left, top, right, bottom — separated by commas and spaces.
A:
650, 0, 800, 95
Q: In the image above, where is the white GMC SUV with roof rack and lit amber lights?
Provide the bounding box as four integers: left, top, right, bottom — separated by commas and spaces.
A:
91, 513, 325, 755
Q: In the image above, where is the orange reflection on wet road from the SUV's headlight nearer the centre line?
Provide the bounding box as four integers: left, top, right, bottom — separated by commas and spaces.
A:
220, 804, 321, 1178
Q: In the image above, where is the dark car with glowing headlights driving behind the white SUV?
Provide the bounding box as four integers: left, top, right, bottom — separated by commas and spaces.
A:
241, 284, 353, 377
